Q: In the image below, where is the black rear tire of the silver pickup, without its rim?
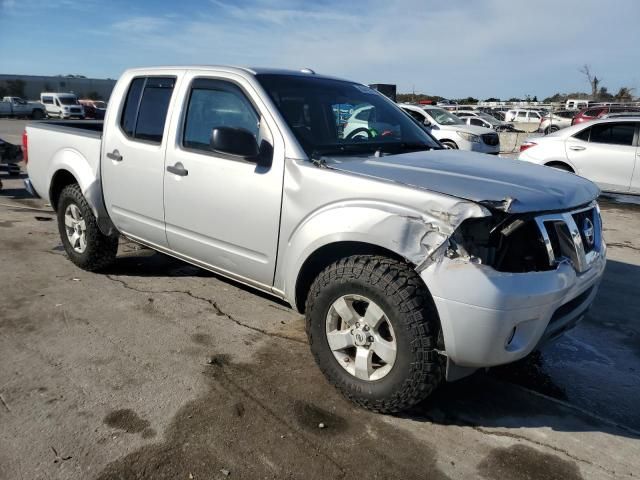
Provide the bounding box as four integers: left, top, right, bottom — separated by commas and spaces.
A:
57, 183, 118, 272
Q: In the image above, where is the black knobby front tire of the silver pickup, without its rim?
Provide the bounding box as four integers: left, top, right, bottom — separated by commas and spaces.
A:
306, 255, 442, 413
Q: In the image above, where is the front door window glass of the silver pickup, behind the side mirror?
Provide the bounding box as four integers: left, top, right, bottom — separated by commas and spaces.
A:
182, 79, 260, 151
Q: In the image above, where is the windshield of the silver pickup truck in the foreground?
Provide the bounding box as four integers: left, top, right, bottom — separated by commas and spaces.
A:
257, 74, 441, 157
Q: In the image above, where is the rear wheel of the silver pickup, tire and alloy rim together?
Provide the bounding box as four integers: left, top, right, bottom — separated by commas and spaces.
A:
58, 184, 118, 272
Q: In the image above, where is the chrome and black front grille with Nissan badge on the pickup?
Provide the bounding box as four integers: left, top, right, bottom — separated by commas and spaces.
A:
536, 202, 602, 273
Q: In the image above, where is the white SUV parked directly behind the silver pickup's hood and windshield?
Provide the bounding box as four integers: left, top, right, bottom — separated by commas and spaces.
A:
400, 105, 500, 155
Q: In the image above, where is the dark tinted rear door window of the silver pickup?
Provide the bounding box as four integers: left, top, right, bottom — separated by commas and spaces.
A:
120, 77, 175, 143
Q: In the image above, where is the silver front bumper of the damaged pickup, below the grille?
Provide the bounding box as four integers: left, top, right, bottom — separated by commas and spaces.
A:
421, 248, 606, 378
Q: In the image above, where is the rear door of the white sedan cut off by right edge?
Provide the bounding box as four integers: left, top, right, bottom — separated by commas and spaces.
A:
566, 122, 638, 192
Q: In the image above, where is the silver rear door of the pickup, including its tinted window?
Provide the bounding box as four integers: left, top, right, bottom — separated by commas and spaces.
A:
101, 72, 177, 247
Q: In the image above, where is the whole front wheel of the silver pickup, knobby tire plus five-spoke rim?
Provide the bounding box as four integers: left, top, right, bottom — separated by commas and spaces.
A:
306, 255, 442, 413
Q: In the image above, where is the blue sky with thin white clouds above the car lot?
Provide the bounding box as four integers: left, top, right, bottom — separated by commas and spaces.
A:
0, 0, 640, 99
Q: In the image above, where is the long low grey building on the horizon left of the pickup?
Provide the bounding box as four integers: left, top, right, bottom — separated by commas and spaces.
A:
0, 74, 116, 100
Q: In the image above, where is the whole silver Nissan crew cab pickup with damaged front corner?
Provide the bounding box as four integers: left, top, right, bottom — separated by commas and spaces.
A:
23, 66, 605, 412
